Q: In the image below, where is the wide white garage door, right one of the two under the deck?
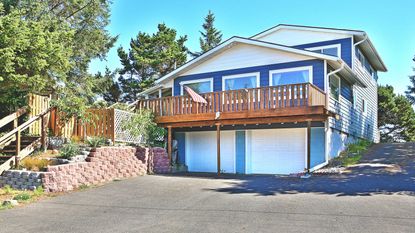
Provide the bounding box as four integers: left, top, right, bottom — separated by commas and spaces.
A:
247, 129, 306, 174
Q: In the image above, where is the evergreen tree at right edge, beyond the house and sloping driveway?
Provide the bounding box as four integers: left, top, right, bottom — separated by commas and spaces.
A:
378, 85, 415, 142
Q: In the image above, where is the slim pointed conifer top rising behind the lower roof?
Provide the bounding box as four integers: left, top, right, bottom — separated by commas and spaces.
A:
190, 10, 222, 57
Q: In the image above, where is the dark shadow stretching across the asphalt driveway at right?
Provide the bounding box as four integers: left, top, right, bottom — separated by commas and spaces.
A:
162, 143, 415, 196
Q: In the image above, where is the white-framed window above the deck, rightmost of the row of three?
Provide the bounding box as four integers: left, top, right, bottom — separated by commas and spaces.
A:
269, 66, 313, 86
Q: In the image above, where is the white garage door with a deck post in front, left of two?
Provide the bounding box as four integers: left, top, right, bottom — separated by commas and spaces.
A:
185, 131, 235, 173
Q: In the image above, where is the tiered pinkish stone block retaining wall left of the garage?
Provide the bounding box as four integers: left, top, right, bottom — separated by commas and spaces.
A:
0, 147, 170, 192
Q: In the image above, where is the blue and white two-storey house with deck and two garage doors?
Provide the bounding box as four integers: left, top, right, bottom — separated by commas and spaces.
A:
137, 25, 387, 174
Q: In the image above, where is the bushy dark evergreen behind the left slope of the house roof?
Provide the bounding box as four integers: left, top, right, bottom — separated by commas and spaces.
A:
118, 24, 187, 102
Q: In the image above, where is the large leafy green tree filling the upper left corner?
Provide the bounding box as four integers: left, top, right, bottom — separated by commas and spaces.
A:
0, 0, 117, 117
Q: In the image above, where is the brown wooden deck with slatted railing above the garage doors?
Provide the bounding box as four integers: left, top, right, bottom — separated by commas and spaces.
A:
137, 83, 328, 127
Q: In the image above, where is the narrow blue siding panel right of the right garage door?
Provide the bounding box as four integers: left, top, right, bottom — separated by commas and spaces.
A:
310, 128, 326, 167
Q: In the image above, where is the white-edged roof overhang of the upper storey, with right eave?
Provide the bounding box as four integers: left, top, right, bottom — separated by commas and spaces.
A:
251, 24, 388, 71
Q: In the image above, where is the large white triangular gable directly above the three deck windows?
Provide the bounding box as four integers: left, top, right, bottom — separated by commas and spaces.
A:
182, 43, 314, 75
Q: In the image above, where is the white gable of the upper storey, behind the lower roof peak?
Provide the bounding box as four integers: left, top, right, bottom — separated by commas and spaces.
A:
253, 28, 351, 46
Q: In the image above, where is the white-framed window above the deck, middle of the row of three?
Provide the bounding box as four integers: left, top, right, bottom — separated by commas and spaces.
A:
222, 73, 259, 91
